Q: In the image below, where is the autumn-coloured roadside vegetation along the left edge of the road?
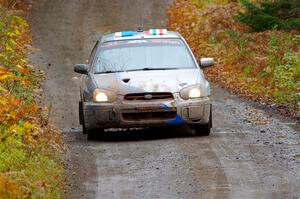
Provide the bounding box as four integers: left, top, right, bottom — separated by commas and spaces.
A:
0, 4, 64, 198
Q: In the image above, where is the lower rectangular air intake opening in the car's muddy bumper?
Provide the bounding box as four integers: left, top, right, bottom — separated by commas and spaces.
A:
122, 111, 176, 121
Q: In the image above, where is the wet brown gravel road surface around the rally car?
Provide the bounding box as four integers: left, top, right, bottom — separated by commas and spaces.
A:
31, 0, 300, 198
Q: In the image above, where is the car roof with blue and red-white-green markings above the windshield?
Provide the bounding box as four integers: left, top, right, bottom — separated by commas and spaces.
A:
100, 29, 182, 43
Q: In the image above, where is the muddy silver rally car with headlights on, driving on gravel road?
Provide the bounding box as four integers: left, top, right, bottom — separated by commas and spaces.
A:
74, 29, 214, 140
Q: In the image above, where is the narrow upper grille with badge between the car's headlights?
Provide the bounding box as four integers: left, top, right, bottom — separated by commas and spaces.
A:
124, 92, 174, 101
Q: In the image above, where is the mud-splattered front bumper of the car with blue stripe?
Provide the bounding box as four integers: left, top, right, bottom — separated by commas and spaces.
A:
81, 97, 211, 129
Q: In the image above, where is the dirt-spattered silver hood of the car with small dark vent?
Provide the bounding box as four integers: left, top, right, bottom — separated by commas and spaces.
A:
94, 69, 207, 95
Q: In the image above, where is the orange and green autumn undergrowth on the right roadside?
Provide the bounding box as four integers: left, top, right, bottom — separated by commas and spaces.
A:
168, 0, 300, 119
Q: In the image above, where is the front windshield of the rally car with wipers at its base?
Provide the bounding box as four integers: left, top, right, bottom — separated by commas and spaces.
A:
93, 39, 196, 73
